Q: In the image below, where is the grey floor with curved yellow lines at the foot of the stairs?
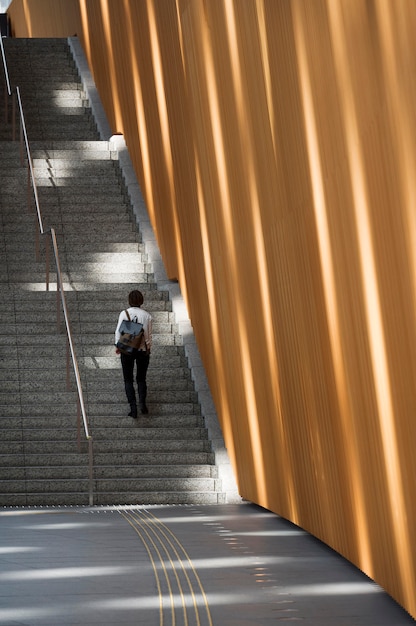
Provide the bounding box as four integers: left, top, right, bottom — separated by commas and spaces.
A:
0, 503, 415, 626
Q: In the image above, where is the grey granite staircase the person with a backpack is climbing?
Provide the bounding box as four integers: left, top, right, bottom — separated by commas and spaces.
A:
0, 39, 224, 506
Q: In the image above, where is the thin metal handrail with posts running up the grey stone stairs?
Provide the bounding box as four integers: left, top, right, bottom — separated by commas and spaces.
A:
0, 37, 94, 506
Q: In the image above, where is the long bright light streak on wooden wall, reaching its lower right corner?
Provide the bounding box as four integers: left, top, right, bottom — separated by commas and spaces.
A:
327, 0, 415, 602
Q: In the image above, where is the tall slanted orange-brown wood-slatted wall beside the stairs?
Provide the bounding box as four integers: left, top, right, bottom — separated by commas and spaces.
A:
9, 0, 416, 617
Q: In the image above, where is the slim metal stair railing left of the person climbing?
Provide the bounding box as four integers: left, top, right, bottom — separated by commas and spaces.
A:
0, 37, 94, 506
